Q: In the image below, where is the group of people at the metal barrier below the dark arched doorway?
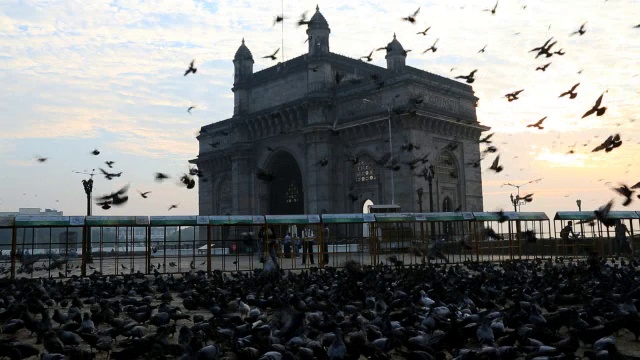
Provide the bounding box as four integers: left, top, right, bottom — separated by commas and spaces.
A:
258, 225, 329, 266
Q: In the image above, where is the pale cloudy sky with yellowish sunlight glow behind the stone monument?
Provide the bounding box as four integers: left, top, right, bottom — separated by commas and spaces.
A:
0, 0, 640, 216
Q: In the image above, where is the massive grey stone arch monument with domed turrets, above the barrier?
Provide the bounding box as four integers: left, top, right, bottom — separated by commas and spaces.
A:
191, 6, 489, 215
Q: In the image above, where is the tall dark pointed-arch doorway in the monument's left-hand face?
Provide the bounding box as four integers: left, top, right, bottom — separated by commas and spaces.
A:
269, 151, 304, 215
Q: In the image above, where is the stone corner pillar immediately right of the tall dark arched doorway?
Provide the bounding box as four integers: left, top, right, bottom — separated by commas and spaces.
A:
301, 128, 341, 214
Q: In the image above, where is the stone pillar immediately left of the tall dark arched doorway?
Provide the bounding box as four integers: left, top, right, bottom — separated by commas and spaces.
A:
231, 145, 255, 215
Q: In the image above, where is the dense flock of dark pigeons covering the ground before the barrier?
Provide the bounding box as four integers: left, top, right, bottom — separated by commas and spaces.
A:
0, 255, 640, 360
